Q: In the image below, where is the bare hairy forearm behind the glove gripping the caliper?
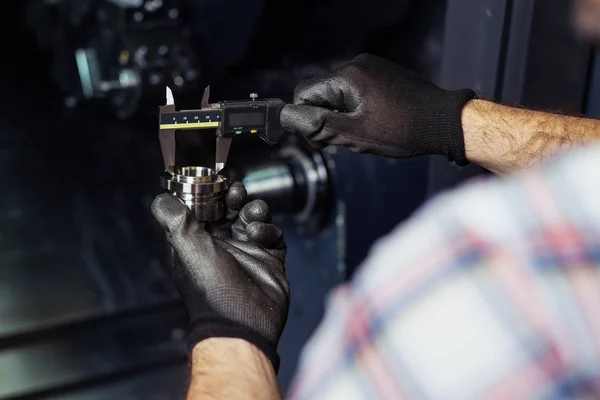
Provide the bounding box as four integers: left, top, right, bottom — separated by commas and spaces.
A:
462, 100, 600, 173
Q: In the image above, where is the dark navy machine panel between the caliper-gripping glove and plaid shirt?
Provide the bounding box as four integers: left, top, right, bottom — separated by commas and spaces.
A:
328, 147, 427, 278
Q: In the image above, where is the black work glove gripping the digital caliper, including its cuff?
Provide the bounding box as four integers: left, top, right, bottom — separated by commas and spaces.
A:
281, 54, 476, 165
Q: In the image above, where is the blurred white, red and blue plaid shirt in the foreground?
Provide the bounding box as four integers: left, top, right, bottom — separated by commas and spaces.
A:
288, 148, 600, 400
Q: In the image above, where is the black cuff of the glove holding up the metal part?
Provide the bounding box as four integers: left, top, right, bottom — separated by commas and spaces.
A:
188, 319, 280, 374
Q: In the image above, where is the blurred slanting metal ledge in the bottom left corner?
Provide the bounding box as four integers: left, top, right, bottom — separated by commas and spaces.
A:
0, 304, 187, 400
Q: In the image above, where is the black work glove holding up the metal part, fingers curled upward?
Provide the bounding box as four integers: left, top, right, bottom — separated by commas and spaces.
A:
152, 183, 290, 371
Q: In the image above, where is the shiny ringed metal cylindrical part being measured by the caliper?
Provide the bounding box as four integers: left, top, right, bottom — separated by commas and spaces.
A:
161, 167, 229, 221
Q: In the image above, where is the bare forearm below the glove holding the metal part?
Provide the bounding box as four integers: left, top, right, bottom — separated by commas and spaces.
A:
187, 338, 281, 400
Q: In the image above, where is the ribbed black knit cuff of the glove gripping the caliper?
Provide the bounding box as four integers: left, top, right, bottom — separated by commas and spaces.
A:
415, 85, 477, 166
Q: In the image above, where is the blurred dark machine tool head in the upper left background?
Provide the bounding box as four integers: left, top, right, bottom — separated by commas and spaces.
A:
28, 0, 202, 118
